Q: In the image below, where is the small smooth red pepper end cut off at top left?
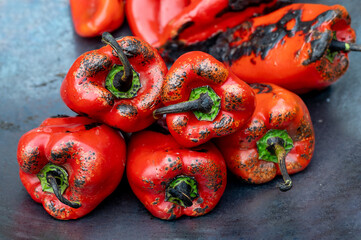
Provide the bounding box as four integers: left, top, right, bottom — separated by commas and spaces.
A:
70, 0, 124, 37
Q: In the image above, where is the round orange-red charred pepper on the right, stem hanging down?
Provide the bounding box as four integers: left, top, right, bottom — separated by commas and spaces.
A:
216, 83, 315, 191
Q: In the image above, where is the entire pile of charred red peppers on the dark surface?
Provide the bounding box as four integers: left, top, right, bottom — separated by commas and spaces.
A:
17, 0, 360, 220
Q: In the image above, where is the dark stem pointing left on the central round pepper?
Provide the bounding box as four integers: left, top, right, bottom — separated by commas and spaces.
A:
153, 93, 213, 117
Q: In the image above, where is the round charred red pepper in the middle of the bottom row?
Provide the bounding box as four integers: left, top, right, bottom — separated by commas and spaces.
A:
126, 131, 227, 220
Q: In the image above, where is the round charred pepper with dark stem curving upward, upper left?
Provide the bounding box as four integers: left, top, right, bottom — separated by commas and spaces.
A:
61, 33, 167, 132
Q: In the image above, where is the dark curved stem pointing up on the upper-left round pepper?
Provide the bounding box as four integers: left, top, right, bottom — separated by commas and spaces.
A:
102, 32, 133, 92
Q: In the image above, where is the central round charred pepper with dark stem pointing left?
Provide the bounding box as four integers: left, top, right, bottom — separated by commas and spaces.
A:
154, 52, 255, 147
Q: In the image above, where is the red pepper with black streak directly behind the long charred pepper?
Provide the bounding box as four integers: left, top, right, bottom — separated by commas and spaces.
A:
154, 0, 279, 48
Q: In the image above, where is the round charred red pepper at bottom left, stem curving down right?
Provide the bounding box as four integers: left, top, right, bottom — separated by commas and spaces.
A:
17, 116, 126, 220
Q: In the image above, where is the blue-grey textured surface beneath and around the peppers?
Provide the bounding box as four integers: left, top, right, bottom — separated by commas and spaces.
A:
0, 0, 361, 239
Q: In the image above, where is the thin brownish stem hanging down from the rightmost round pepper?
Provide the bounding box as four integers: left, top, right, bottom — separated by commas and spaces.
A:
267, 137, 292, 192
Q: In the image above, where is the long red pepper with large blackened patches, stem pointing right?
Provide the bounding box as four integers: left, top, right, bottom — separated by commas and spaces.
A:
160, 4, 359, 93
